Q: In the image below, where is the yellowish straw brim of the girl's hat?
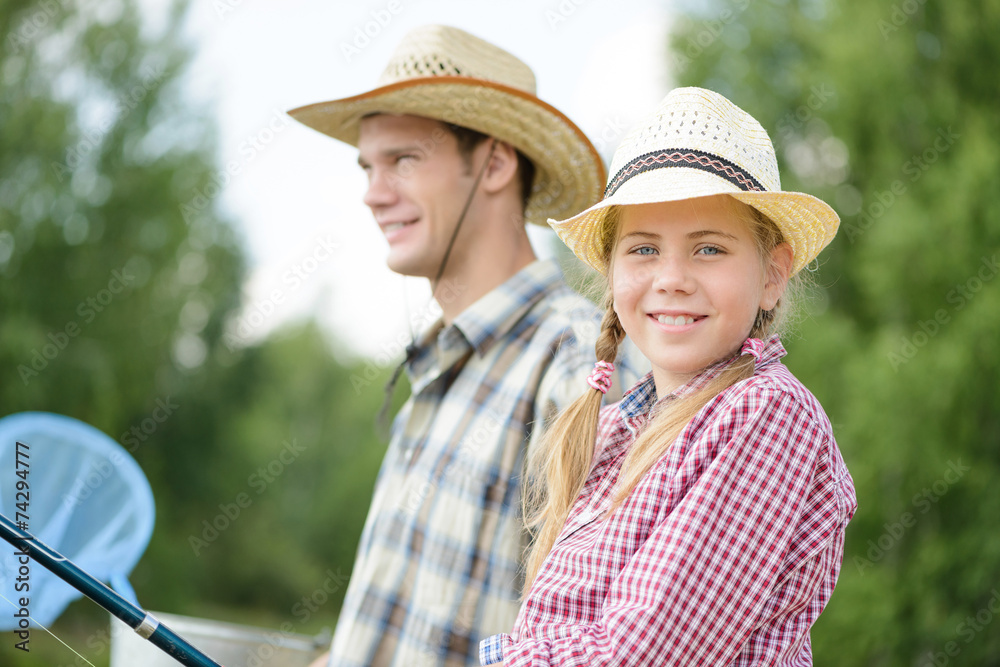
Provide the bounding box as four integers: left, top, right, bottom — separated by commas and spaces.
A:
549, 167, 840, 275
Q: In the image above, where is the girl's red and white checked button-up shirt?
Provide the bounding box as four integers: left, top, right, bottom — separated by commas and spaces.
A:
481, 338, 857, 667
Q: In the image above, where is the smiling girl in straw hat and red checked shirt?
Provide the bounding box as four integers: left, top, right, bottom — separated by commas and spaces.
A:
480, 88, 857, 667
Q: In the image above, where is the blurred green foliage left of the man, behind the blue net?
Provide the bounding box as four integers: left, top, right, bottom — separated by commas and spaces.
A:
0, 0, 405, 667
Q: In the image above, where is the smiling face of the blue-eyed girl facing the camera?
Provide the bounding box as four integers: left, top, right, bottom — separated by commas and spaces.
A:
611, 195, 792, 396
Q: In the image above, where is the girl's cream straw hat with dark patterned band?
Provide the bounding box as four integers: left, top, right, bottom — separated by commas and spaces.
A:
549, 88, 840, 274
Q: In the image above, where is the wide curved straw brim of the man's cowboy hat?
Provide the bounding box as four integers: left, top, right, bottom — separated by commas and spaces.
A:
288, 76, 605, 224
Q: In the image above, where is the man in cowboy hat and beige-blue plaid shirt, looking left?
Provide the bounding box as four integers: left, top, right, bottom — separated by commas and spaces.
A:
290, 26, 635, 667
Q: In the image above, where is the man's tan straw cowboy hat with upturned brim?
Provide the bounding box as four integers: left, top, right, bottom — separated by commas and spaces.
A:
288, 25, 604, 224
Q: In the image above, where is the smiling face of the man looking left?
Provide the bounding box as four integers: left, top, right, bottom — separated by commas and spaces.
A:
358, 114, 475, 279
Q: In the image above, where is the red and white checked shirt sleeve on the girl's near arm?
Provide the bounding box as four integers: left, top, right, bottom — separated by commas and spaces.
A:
504, 390, 837, 667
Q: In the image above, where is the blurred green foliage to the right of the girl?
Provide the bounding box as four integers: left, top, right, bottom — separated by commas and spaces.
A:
671, 0, 1000, 667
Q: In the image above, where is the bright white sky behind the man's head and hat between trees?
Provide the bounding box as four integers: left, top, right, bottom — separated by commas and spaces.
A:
182, 0, 669, 356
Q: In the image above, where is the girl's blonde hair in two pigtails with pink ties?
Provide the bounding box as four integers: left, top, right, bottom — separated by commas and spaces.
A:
523, 197, 803, 596
